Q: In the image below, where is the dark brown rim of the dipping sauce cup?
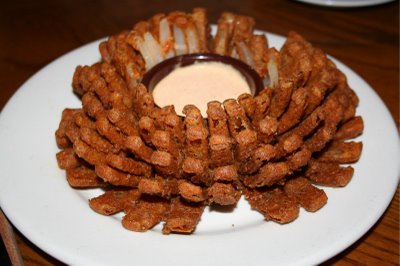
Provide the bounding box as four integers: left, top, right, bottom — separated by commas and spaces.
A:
141, 53, 264, 97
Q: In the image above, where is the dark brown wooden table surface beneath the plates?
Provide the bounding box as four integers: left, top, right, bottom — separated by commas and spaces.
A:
0, 0, 400, 265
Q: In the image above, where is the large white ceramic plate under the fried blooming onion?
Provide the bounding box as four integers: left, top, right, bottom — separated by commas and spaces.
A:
0, 31, 400, 266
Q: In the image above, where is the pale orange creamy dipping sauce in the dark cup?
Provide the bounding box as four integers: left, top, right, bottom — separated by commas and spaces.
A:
153, 62, 251, 117
